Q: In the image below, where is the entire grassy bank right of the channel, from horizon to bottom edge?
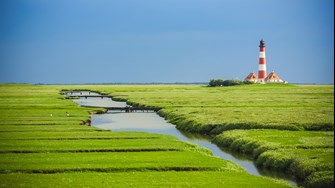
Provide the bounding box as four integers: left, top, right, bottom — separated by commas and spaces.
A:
75, 84, 334, 187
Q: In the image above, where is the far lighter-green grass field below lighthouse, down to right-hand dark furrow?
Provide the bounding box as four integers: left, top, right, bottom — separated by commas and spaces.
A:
78, 84, 334, 134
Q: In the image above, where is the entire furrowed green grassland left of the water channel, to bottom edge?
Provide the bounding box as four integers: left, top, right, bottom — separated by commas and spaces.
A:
0, 85, 289, 187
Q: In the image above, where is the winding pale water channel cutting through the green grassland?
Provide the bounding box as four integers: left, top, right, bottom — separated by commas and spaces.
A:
67, 91, 297, 186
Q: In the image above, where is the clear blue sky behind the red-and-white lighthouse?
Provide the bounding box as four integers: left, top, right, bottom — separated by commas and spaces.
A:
0, 0, 334, 84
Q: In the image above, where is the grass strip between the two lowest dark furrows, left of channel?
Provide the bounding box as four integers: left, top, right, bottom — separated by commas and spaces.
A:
0, 151, 243, 173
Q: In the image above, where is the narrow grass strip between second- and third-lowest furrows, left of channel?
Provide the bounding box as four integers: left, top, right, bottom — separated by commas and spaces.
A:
0, 139, 194, 153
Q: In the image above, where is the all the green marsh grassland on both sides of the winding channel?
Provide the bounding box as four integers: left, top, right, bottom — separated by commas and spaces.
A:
0, 84, 334, 187
